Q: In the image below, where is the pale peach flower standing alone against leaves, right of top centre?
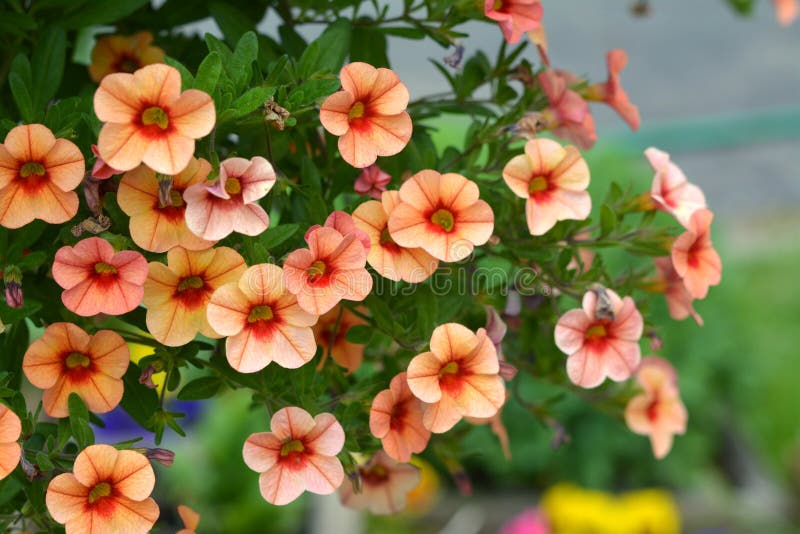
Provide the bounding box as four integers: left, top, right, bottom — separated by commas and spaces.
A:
503, 139, 592, 235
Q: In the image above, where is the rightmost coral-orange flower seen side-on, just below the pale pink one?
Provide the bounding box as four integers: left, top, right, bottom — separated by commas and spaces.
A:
672, 208, 722, 299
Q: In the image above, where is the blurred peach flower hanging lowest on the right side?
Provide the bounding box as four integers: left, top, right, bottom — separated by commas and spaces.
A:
625, 356, 688, 459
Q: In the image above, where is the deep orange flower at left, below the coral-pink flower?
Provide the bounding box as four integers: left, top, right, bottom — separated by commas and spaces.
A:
22, 323, 130, 417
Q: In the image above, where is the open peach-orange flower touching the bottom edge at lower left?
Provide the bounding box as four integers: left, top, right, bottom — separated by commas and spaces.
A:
45, 445, 160, 534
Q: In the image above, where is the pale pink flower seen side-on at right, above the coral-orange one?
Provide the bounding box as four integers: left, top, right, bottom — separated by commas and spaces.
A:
644, 147, 706, 228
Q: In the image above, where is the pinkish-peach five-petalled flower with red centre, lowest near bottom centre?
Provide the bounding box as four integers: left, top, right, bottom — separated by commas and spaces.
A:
242, 406, 344, 505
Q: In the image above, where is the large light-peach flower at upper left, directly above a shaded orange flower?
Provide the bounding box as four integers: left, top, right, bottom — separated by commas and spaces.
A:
94, 63, 216, 176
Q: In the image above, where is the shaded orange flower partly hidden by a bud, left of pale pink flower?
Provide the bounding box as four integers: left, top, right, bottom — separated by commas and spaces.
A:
117, 158, 215, 252
